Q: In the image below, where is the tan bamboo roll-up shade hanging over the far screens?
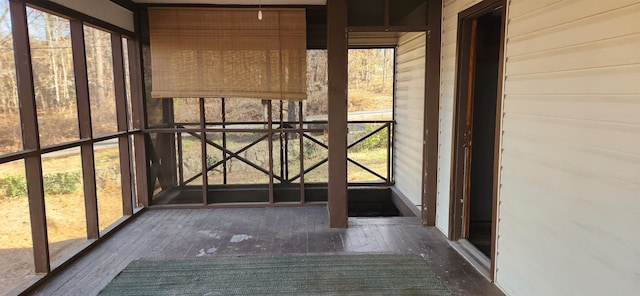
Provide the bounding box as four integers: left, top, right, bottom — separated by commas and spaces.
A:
149, 7, 307, 100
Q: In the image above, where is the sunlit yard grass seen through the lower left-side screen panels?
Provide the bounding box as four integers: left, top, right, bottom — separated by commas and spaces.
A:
0, 147, 122, 249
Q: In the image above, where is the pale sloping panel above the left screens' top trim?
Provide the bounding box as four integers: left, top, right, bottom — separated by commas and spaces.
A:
51, 0, 135, 32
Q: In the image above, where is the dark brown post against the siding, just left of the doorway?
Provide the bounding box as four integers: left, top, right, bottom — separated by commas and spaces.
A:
421, 0, 442, 226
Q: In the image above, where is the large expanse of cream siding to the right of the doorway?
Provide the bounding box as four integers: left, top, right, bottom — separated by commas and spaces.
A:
496, 0, 640, 295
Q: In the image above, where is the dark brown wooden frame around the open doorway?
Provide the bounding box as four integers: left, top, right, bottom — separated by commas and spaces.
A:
448, 0, 507, 281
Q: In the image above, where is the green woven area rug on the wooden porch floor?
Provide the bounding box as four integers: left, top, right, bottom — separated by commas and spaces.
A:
100, 255, 450, 296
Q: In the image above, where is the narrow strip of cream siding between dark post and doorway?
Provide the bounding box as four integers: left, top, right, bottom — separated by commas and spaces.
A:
436, 0, 482, 234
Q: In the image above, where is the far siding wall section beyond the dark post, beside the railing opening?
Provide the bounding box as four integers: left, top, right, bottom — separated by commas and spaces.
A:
393, 33, 426, 208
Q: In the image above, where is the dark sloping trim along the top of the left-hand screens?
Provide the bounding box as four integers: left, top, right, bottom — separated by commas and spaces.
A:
22, 0, 136, 37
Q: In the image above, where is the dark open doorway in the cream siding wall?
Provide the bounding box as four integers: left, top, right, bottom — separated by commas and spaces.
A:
449, 1, 504, 267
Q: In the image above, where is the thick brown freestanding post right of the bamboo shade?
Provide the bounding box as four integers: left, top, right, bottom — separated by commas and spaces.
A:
327, 0, 348, 228
